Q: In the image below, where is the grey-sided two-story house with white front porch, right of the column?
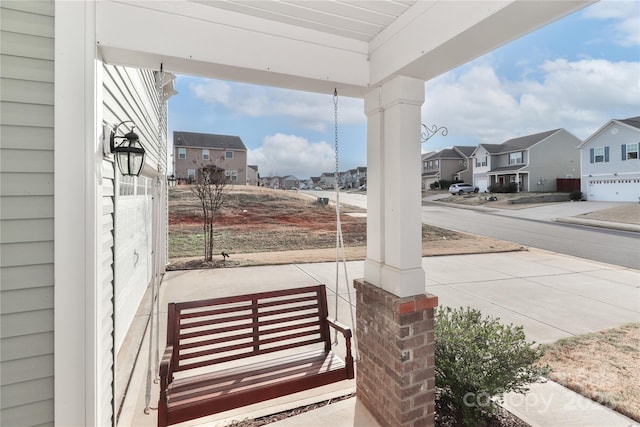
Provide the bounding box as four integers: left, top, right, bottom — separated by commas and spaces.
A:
472, 129, 581, 191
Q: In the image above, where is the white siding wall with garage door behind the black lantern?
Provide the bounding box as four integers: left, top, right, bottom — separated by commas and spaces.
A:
100, 64, 167, 422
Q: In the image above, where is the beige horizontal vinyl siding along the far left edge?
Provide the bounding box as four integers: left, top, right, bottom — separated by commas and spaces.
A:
0, 1, 54, 426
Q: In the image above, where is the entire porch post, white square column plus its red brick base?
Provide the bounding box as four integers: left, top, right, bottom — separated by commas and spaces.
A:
354, 76, 438, 427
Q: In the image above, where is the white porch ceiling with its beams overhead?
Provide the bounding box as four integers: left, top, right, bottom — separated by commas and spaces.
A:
96, 0, 593, 97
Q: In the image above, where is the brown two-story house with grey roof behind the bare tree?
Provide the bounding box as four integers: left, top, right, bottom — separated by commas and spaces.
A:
173, 131, 247, 185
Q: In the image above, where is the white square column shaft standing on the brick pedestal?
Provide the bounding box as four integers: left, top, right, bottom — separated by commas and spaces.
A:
364, 76, 425, 297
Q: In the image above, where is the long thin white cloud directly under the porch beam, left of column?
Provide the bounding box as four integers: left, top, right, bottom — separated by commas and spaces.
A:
189, 79, 366, 132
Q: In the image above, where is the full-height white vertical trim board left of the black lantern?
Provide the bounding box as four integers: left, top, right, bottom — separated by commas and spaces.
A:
54, 1, 100, 426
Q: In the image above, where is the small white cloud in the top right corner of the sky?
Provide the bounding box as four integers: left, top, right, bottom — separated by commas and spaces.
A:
583, 0, 640, 47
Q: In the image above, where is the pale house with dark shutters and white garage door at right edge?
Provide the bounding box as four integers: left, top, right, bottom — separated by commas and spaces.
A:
579, 116, 640, 202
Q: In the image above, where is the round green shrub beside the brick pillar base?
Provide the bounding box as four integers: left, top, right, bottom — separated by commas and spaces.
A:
435, 307, 545, 426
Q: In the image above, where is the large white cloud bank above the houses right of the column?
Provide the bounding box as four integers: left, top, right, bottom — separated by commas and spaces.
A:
423, 59, 640, 149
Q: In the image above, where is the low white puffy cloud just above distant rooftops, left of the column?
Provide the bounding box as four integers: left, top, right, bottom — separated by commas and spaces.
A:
247, 133, 335, 178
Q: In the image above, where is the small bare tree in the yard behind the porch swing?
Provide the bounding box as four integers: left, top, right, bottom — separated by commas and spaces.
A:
191, 165, 229, 261
